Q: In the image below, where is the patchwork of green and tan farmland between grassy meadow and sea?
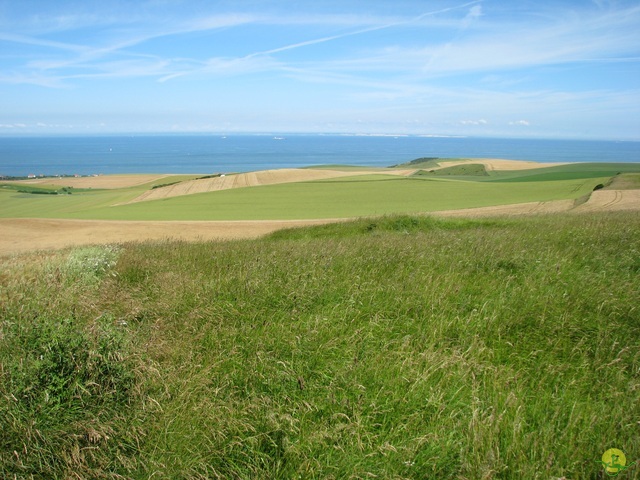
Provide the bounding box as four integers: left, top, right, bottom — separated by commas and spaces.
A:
0, 159, 640, 255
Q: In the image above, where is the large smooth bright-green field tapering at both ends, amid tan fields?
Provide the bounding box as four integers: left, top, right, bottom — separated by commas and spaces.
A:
104, 175, 604, 220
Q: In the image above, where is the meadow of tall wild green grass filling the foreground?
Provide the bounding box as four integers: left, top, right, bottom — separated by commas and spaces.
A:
0, 212, 640, 479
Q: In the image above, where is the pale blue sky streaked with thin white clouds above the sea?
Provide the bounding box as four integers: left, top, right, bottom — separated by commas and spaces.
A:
0, 0, 640, 140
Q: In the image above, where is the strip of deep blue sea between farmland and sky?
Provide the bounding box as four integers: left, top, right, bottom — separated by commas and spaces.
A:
0, 134, 640, 177
